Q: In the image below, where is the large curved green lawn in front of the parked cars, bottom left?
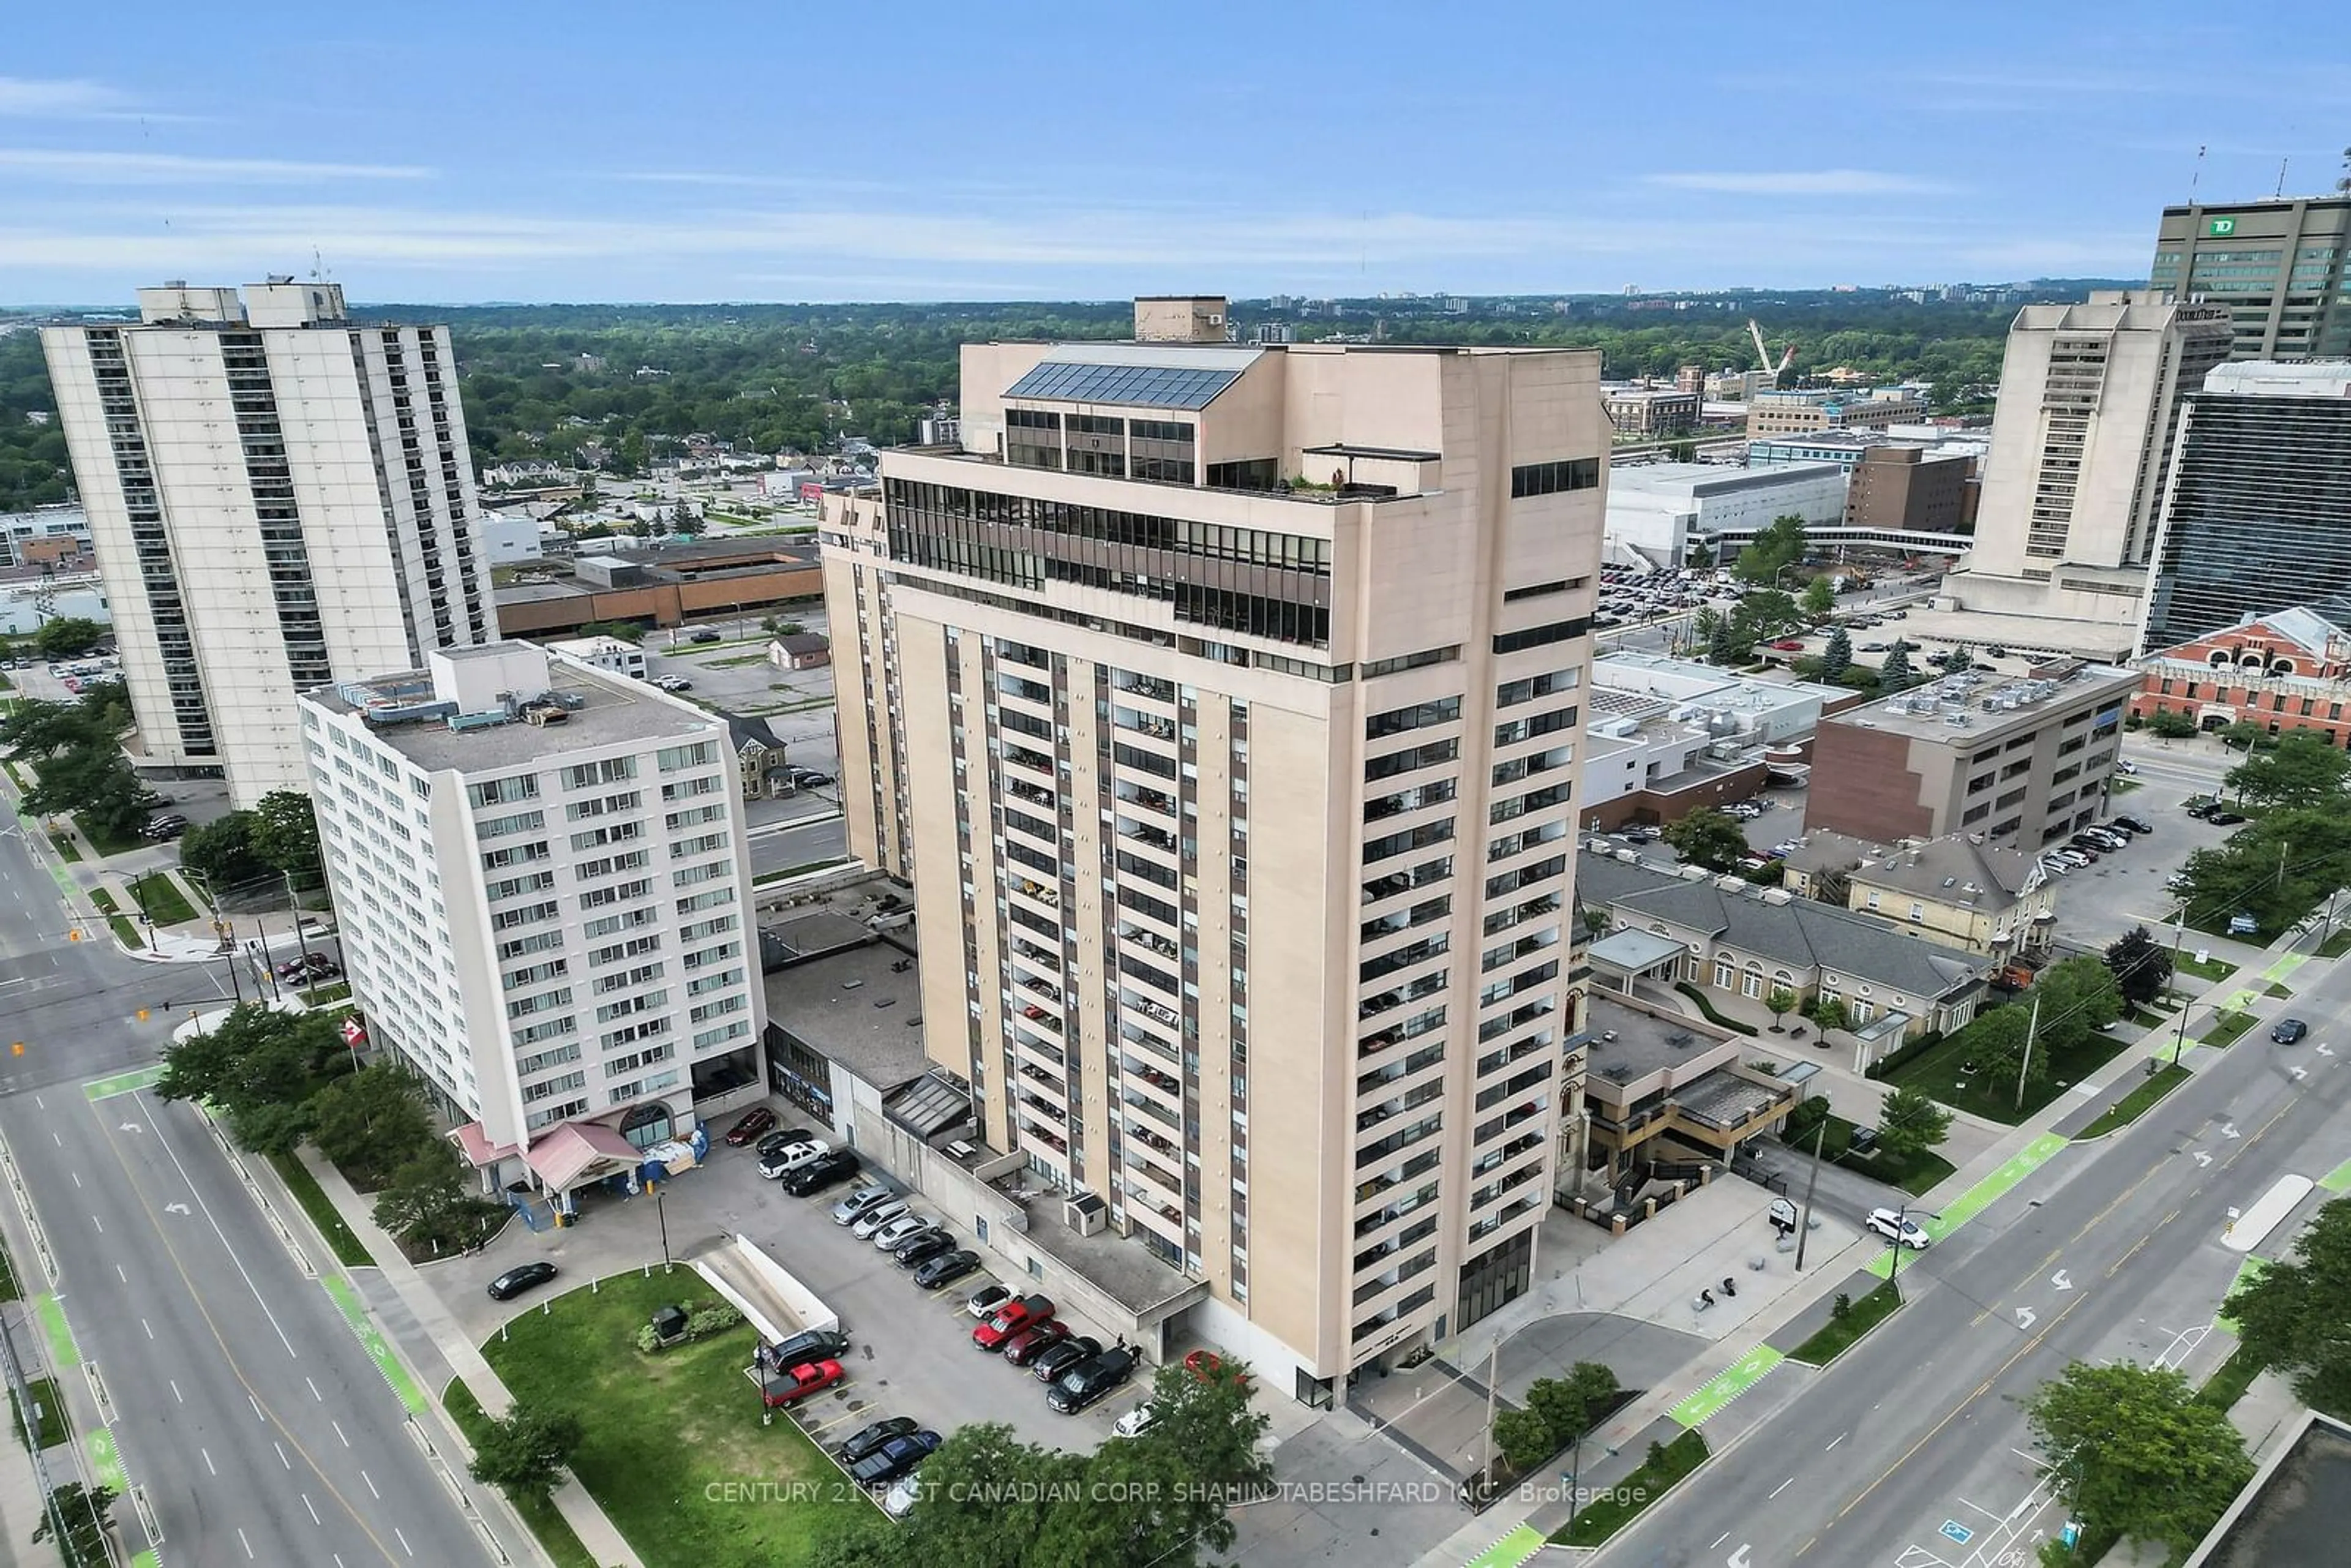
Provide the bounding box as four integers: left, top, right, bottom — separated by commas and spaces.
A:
482, 1274, 868, 1568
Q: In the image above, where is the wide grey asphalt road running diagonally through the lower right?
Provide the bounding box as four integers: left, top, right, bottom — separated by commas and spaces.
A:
1603, 950, 2351, 1568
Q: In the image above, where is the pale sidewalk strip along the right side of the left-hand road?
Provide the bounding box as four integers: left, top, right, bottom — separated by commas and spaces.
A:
289, 1145, 644, 1568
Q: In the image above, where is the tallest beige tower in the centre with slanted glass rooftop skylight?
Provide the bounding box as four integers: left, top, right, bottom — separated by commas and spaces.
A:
820, 301, 1608, 1401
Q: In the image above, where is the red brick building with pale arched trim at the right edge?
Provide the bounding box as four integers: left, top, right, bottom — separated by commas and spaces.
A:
2130, 609, 2351, 745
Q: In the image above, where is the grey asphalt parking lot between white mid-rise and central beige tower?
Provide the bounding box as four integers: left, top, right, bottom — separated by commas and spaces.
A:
441, 1103, 1152, 1448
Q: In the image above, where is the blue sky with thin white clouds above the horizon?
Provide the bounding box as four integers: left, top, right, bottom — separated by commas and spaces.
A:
0, 0, 2351, 303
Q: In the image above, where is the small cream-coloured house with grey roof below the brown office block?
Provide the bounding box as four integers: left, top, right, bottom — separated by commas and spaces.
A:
1780, 830, 2057, 961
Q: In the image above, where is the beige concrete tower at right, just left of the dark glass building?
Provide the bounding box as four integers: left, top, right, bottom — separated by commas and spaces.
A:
1947, 291, 2229, 639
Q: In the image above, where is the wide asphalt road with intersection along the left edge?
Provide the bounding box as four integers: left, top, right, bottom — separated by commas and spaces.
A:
0, 804, 500, 1568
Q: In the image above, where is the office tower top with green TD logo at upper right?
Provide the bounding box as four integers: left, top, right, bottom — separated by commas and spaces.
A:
2147, 195, 2351, 359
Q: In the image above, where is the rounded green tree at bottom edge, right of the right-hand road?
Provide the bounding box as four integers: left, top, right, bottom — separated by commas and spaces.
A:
2024, 1361, 2252, 1561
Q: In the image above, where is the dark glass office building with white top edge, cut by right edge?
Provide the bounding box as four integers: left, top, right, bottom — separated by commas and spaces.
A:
2139, 359, 2351, 653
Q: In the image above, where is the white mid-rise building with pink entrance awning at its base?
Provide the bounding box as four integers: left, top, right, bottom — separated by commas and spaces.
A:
299, 642, 767, 1190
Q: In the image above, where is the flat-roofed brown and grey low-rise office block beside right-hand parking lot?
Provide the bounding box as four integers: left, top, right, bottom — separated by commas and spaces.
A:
1805, 661, 2139, 851
